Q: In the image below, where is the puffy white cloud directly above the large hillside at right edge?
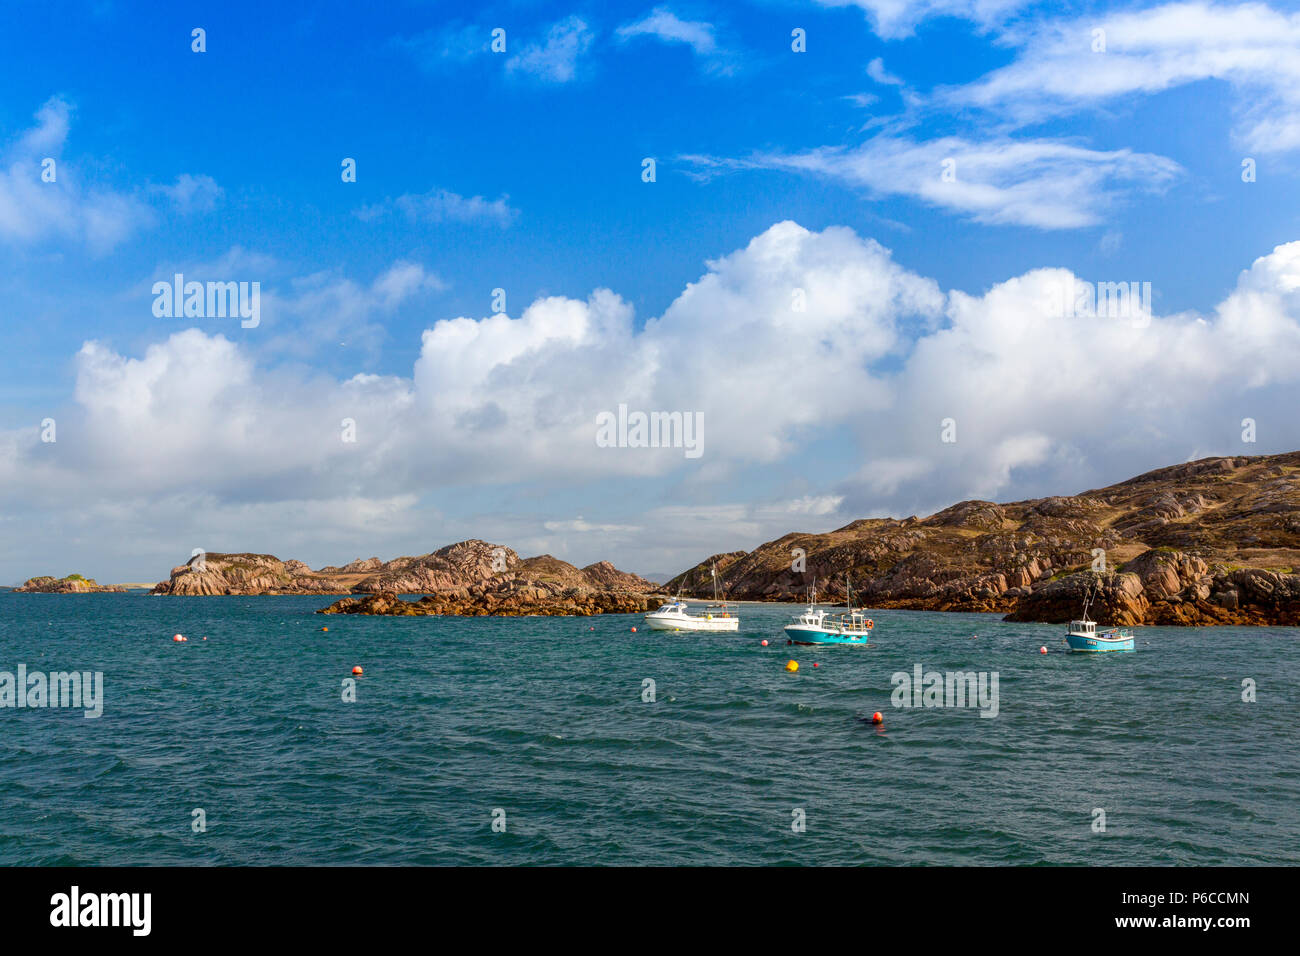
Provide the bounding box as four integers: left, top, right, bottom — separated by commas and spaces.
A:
849, 236, 1300, 509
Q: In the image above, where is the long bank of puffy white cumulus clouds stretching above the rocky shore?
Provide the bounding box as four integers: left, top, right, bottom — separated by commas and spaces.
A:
0, 222, 1300, 580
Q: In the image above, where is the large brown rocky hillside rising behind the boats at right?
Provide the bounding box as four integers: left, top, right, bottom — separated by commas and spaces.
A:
666, 453, 1300, 626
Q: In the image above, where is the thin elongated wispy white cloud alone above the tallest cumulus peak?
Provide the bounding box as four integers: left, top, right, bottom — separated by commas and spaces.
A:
683, 134, 1182, 229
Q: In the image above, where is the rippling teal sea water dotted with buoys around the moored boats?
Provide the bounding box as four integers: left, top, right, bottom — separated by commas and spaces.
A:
0, 592, 1300, 865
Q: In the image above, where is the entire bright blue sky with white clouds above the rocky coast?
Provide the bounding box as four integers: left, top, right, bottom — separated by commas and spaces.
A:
0, 0, 1300, 584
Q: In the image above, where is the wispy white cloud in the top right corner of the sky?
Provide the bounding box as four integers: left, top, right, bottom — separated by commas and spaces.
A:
935, 3, 1300, 153
